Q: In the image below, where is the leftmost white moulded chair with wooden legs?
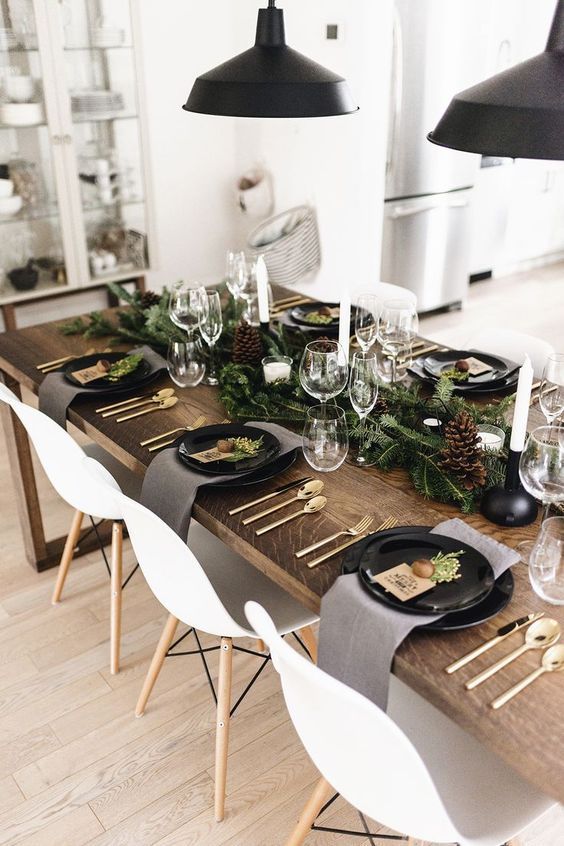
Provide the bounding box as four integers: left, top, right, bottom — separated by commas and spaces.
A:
0, 382, 140, 673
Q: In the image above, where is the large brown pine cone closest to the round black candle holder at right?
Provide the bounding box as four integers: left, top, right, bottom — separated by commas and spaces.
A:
441, 411, 487, 491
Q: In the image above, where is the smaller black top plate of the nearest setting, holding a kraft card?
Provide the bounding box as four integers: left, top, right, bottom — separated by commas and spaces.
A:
358, 532, 495, 614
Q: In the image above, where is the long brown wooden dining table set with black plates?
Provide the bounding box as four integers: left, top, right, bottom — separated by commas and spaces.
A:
0, 304, 564, 803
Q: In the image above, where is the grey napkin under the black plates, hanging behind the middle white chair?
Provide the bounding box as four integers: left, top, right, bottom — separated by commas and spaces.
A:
141, 423, 302, 539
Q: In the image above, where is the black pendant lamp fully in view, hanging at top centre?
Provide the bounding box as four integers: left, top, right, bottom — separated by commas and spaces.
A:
183, 0, 358, 118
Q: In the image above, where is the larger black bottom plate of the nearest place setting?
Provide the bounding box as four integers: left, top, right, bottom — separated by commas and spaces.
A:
341, 526, 515, 632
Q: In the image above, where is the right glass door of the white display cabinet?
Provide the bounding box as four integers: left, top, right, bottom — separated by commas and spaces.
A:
57, 0, 148, 279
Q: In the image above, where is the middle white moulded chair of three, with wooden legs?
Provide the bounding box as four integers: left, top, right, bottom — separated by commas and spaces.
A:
85, 459, 318, 821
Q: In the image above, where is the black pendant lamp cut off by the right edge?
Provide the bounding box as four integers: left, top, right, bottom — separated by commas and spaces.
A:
427, 0, 564, 159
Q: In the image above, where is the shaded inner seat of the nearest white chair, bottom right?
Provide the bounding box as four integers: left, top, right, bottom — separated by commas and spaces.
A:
388, 676, 555, 846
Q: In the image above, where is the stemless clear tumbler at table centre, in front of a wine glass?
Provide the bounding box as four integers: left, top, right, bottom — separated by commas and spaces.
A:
302, 405, 349, 473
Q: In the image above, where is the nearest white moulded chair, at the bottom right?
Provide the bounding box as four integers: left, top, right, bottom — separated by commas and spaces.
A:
245, 602, 554, 846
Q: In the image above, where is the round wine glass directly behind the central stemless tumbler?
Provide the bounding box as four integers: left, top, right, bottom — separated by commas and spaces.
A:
299, 341, 349, 404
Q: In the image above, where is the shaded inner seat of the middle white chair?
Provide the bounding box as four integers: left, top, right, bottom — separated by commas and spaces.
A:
188, 520, 319, 634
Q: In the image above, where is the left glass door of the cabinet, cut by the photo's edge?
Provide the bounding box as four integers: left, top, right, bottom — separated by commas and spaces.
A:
0, 0, 67, 302
